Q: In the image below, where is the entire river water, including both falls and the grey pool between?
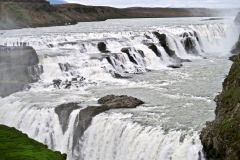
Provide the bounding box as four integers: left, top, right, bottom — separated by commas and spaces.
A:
0, 18, 238, 160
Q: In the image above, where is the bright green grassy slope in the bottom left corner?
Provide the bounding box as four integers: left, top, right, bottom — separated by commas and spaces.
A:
0, 125, 67, 160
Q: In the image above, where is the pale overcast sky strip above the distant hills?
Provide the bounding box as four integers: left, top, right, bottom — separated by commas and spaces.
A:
50, 0, 240, 8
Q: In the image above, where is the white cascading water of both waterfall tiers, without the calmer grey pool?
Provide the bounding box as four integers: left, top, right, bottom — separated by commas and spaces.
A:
0, 18, 238, 160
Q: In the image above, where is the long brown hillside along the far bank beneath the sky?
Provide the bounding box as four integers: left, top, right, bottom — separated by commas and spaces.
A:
0, 0, 231, 29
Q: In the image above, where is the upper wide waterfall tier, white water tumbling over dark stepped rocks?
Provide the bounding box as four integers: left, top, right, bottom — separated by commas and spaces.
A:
0, 18, 236, 88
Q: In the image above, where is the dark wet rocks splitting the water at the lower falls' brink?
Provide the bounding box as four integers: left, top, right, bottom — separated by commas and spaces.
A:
55, 95, 144, 142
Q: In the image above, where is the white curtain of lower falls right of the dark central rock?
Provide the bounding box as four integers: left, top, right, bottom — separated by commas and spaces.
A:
81, 114, 204, 160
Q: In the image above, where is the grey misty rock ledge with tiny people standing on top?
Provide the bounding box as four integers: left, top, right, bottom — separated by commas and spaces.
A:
0, 46, 43, 97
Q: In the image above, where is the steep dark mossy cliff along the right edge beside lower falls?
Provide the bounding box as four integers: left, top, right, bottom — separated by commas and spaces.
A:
200, 55, 240, 160
